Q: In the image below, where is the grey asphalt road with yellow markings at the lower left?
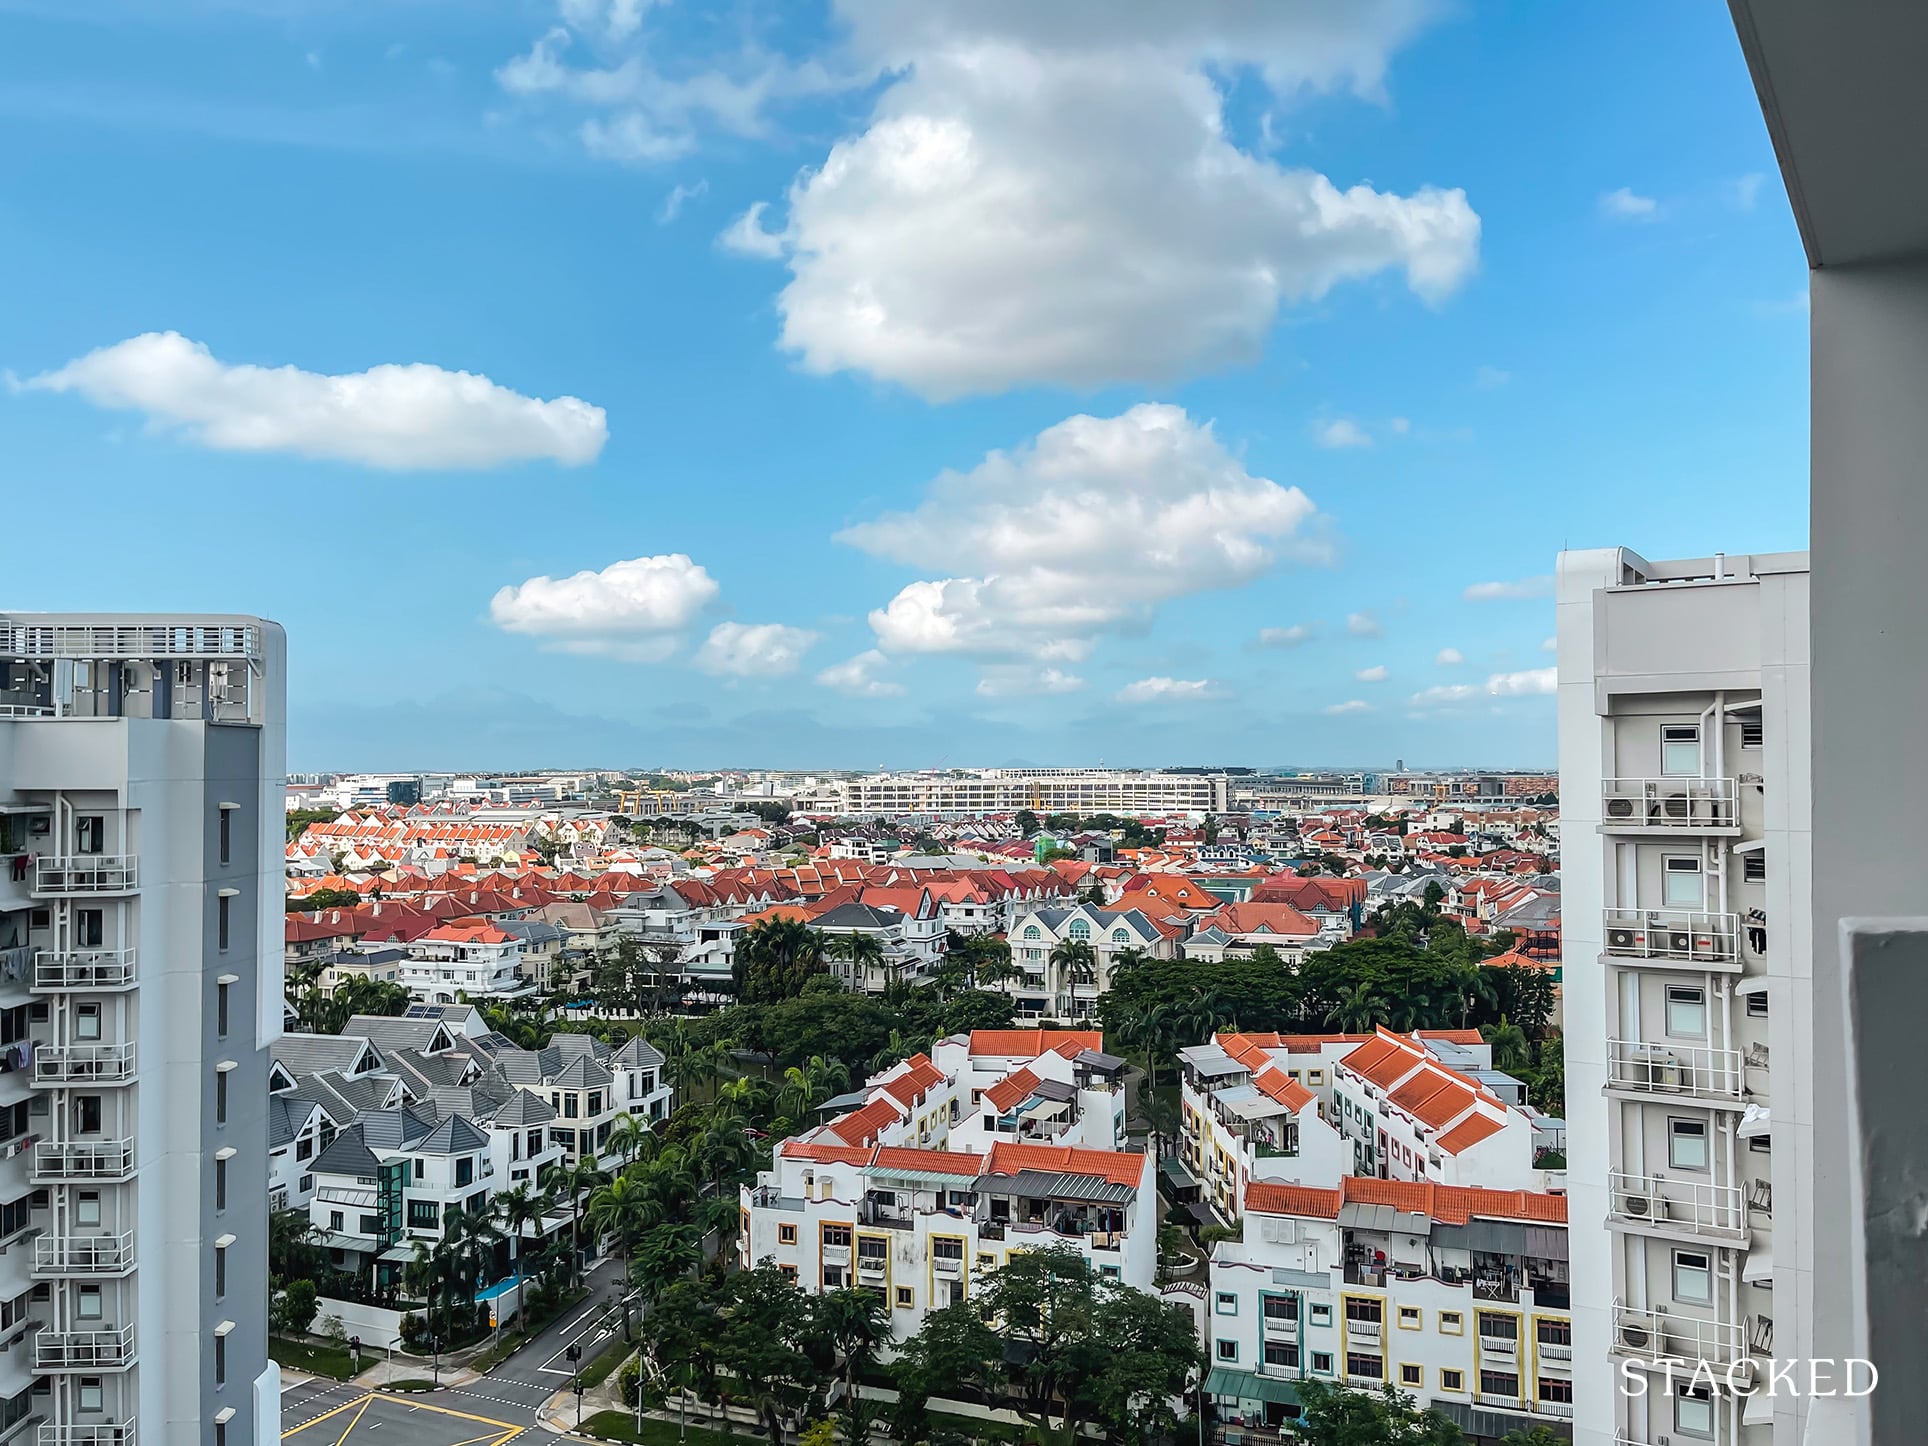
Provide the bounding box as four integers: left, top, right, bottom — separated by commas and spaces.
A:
281, 1261, 623, 1446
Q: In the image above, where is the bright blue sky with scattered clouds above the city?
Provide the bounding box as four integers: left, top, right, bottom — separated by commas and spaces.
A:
0, 0, 1807, 767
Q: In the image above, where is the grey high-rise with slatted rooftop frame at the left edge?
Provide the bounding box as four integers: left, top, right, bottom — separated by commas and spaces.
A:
0, 613, 285, 1446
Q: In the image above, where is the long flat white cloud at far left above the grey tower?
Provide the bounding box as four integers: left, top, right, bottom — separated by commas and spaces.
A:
15, 332, 609, 470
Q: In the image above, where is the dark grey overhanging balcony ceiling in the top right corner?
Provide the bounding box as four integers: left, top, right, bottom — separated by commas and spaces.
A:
1729, 0, 1928, 266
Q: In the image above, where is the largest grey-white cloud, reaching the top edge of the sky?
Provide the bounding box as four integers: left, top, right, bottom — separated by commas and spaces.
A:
728, 0, 1481, 399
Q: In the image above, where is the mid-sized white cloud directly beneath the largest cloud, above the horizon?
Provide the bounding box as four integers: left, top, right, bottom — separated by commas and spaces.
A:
839, 403, 1319, 663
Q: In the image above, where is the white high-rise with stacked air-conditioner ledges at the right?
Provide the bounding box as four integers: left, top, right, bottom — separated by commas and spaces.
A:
1558, 548, 1816, 1446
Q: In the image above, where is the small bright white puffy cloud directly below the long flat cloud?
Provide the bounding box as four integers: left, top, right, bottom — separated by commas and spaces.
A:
488, 551, 717, 663
